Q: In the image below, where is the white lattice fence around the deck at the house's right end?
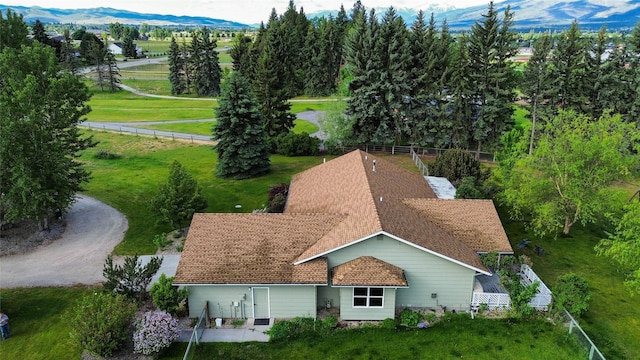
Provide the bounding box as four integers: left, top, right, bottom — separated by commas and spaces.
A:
471, 264, 552, 310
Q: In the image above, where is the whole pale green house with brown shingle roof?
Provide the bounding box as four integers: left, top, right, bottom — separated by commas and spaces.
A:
174, 150, 513, 320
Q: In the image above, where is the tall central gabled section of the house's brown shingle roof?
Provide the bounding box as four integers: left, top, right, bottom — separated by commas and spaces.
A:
286, 150, 486, 270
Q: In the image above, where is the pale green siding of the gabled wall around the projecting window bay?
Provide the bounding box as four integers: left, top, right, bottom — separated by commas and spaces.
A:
327, 236, 475, 310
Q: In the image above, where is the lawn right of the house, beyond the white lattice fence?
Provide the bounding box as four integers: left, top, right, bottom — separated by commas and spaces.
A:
500, 179, 640, 359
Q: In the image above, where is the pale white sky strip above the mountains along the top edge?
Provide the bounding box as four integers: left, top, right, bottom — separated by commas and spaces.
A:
0, 0, 500, 24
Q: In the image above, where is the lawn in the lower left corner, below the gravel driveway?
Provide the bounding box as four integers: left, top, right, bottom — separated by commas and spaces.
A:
0, 287, 94, 360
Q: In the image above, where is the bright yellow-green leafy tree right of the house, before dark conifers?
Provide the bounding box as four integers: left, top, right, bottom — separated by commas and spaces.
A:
504, 111, 640, 236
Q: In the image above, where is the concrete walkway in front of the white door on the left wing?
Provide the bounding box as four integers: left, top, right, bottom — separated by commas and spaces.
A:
176, 319, 273, 342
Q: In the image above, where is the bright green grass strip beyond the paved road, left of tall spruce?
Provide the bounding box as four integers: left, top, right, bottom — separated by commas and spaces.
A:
87, 91, 218, 122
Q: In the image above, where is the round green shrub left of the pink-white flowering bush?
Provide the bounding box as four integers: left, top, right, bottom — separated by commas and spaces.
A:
66, 292, 136, 357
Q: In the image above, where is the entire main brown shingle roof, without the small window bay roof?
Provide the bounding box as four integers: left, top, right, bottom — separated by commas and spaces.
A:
174, 150, 512, 285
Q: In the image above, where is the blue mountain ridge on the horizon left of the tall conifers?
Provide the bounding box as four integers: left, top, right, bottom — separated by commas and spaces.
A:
0, 4, 250, 29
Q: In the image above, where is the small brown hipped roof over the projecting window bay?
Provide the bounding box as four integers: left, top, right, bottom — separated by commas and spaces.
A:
331, 256, 407, 286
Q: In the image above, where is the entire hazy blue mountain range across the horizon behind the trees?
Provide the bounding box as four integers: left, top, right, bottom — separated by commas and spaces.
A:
0, 0, 640, 31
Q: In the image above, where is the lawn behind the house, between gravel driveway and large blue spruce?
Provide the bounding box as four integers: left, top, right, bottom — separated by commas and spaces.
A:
81, 130, 322, 255
